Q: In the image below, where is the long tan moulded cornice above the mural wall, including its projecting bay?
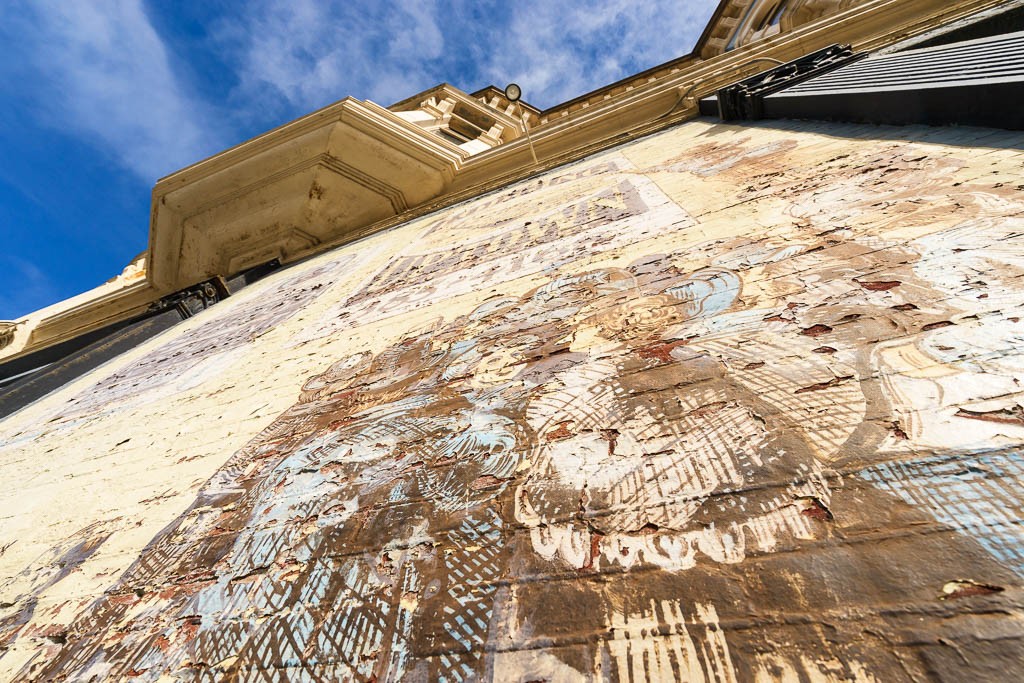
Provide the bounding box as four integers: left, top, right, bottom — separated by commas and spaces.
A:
0, 0, 1002, 366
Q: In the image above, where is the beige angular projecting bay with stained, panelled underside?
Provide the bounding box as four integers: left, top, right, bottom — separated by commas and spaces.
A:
147, 98, 468, 292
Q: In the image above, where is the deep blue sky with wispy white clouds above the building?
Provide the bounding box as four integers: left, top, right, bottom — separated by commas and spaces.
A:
0, 0, 718, 319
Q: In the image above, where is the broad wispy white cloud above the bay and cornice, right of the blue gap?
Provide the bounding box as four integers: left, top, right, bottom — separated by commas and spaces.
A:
211, 0, 717, 113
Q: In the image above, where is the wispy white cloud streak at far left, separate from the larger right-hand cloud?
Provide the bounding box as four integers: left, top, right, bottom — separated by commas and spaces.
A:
0, 0, 221, 182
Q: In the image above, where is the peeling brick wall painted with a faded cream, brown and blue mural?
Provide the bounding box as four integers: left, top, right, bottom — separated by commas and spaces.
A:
0, 122, 1024, 682
